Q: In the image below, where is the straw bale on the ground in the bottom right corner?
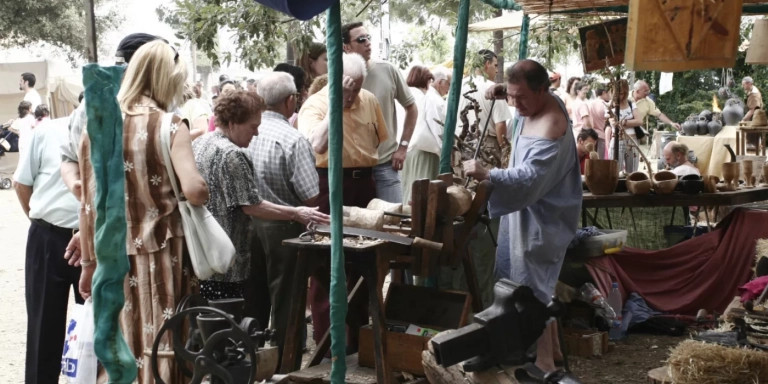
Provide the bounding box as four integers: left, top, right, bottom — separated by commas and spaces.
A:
667, 340, 768, 384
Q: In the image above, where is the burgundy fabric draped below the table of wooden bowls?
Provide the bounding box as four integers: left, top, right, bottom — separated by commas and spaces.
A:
587, 208, 768, 315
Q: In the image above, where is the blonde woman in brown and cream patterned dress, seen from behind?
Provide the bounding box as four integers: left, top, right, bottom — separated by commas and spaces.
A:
80, 40, 208, 383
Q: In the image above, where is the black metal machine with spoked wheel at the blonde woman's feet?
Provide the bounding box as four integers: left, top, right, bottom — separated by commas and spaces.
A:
151, 307, 258, 384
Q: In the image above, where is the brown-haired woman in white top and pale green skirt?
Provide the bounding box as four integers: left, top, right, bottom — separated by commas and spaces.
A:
400, 65, 445, 204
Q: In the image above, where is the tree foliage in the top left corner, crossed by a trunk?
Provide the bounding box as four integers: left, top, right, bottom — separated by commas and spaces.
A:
0, 0, 121, 61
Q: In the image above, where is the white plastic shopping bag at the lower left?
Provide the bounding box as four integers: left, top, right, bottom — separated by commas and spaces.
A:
61, 299, 98, 384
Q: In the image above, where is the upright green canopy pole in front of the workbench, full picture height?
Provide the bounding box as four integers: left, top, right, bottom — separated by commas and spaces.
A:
326, 0, 347, 383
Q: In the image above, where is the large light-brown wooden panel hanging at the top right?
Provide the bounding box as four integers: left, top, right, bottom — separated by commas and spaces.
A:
625, 0, 742, 72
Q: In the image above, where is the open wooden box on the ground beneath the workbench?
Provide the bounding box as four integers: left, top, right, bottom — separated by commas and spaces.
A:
358, 284, 472, 376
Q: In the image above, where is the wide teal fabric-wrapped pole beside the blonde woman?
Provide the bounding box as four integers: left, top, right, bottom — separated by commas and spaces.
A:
83, 64, 138, 384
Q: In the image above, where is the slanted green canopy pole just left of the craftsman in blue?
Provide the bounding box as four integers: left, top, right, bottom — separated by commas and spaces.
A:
440, 0, 469, 173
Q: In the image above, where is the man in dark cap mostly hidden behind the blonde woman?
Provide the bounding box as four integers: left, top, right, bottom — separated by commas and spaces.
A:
61, 33, 167, 200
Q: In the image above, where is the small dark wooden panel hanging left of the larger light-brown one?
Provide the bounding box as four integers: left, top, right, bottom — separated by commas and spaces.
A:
579, 18, 627, 72
